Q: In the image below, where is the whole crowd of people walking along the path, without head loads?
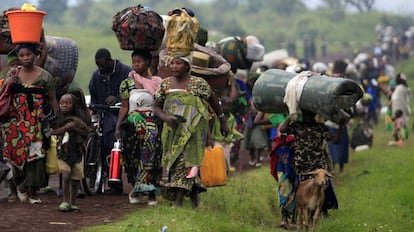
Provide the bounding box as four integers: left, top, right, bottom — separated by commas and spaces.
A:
0, 5, 411, 232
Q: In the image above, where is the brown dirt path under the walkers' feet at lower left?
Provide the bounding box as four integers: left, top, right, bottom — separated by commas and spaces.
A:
0, 148, 256, 232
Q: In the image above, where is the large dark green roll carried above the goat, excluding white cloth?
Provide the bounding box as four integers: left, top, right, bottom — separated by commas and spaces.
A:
252, 69, 363, 122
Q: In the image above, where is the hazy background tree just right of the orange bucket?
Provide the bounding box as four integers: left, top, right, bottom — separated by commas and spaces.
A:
38, 0, 68, 23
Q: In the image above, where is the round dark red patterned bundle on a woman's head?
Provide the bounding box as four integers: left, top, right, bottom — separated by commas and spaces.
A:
112, 4, 165, 51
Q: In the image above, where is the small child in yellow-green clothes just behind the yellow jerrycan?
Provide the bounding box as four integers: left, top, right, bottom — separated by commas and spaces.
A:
212, 96, 243, 171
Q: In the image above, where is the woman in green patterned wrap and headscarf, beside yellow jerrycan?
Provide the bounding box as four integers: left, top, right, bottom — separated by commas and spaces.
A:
155, 56, 229, 208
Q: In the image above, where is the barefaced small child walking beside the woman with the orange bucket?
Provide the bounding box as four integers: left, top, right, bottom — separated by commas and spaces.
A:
52, 89, 88, 212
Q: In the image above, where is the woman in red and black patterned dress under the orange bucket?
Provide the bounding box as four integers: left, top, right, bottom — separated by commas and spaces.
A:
0, 43, 58, 204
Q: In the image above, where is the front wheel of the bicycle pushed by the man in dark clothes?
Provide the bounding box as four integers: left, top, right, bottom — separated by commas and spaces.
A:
82, 132, 103, 196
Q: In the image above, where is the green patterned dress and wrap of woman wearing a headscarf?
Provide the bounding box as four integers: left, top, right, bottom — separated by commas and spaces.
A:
155, 77, 211, 198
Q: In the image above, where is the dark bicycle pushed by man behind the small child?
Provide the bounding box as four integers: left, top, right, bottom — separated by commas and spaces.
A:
82, 103, 121, 196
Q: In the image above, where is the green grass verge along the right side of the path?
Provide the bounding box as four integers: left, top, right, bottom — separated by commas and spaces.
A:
83, 117, 414, 232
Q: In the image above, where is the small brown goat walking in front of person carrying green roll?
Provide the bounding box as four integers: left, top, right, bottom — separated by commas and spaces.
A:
296, 169, 332, 231
